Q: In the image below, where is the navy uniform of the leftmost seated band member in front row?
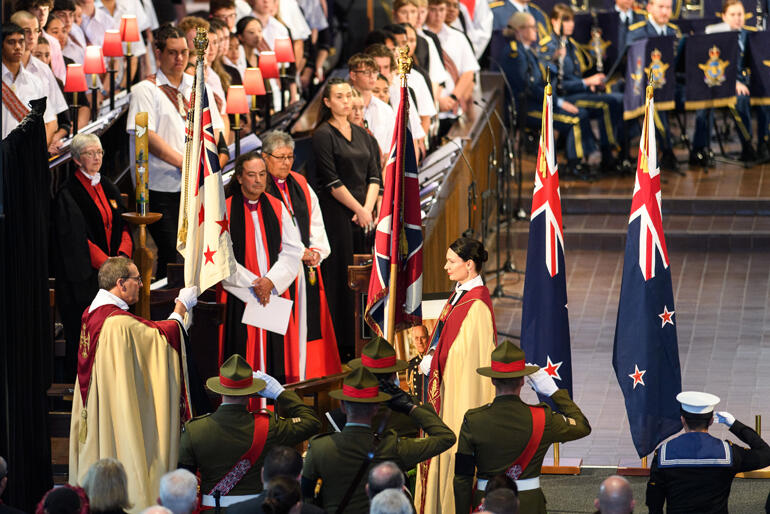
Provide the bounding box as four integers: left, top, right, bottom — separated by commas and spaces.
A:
493, 40, 595, 161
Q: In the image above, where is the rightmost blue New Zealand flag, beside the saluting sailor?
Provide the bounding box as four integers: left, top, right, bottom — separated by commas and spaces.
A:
612, 86, 682, 457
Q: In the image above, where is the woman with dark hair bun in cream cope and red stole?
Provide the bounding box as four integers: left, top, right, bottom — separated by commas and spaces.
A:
415, 237, 497, 512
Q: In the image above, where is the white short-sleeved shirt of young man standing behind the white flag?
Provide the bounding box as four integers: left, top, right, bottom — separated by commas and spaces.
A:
126, 70, 223, 189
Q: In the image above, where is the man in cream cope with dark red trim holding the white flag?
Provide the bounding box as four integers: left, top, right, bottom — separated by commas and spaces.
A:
69, 257, 198, 508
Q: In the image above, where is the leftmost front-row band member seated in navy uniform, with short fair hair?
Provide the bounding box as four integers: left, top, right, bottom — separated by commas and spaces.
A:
493, 11, 596, 178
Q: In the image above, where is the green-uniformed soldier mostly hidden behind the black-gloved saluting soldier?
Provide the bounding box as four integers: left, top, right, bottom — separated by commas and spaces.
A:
326, 337, 420, 437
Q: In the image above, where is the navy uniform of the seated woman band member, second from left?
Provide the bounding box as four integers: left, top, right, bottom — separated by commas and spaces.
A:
540, 36, 623, 155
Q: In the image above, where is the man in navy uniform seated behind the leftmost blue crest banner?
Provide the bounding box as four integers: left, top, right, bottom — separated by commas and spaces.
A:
626, 0, 682, 171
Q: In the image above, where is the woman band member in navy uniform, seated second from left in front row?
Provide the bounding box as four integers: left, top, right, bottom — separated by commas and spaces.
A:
540, 3, 624, 171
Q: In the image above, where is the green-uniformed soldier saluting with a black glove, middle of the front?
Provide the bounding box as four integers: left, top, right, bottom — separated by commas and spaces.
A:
302, 366, 456, 514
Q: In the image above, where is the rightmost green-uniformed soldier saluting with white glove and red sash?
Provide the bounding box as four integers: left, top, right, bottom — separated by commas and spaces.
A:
454, 341, 591, 514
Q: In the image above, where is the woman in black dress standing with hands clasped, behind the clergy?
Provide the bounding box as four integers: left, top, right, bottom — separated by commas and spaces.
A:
313, 79, 382, 362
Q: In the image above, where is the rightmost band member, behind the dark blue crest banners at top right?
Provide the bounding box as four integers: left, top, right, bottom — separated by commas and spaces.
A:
690, 0, 763, 166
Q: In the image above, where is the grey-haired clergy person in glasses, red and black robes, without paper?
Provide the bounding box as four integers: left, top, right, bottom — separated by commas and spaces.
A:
262, 130, 341, 380
